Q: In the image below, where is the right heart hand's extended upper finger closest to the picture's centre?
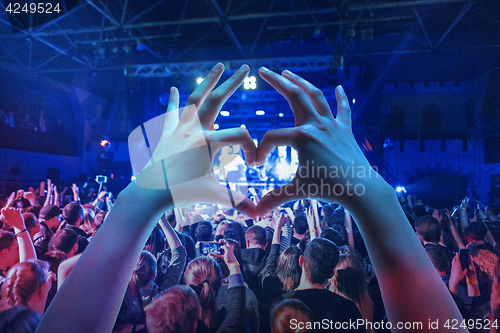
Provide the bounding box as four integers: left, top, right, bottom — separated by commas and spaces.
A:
259, 67, 318, 125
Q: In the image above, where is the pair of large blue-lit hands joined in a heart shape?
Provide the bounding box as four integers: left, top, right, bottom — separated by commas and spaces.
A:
129, 63, 376, 218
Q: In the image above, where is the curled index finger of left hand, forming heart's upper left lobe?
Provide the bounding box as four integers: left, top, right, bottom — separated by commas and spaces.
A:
206, 127, 257, 166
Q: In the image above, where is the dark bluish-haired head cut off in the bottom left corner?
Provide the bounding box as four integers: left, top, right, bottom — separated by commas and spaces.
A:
0, 306, 42, 333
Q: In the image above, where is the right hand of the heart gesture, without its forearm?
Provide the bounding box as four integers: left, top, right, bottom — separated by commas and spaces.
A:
256, 68, 376, 216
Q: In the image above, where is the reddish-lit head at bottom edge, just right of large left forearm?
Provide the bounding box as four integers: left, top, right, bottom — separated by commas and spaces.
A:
146, 285, 200, 333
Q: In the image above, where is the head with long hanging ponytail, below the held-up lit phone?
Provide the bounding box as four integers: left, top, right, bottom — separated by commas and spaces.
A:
184, 257, 222, 329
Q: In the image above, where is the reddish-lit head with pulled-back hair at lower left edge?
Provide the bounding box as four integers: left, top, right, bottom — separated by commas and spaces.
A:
2, 260, 53, 314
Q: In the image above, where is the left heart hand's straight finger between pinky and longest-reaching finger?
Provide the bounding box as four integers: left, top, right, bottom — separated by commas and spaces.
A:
181, 62, 224, 122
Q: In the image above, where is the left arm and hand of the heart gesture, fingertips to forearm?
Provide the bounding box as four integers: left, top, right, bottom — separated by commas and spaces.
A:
37, 64, 256, 333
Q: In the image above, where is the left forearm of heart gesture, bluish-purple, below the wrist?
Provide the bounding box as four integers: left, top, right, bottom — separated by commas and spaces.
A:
37, 182, 173, 333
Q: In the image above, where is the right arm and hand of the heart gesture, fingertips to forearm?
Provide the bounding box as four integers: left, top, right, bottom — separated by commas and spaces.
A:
256, 68, 467, 332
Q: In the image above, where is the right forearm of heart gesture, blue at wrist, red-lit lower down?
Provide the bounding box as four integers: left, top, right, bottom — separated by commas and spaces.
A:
343, 178, 465, 331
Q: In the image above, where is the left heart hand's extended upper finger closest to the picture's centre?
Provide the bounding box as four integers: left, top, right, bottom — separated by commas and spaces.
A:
198, 65, 250, 130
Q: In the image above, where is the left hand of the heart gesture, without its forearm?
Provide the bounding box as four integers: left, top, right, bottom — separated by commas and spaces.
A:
129, 63, 256, 217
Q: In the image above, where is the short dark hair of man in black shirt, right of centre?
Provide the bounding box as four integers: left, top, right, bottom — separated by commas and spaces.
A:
302, 237, 339, 284
